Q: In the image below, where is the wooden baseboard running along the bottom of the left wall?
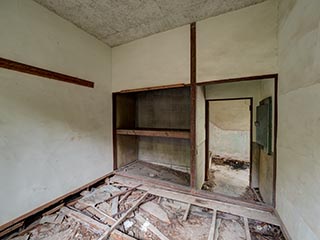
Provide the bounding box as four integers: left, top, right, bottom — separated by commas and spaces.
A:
0, 172, 114, 237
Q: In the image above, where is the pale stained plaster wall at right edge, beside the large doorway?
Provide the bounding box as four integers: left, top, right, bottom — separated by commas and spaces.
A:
277, 0, 320, 240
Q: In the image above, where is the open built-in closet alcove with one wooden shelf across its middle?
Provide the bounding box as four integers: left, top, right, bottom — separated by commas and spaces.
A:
114, 87, 190, 185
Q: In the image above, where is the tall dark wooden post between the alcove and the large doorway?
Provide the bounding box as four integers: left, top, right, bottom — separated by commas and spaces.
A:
190, 23, 197, 188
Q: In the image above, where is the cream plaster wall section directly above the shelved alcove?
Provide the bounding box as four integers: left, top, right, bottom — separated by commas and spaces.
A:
112, 25, 190, 91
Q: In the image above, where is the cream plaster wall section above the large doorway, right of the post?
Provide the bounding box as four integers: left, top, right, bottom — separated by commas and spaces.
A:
197, 0, 278, 82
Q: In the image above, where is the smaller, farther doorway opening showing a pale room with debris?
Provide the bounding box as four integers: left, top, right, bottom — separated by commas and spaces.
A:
203, 98, 254, 200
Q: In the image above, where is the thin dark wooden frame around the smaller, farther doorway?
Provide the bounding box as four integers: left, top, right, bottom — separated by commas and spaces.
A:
205, 97, 253, 184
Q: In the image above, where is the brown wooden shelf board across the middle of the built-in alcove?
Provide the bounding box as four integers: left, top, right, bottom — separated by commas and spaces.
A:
117, 129, 190, 139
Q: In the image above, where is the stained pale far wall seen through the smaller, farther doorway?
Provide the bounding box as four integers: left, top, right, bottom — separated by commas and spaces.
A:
209, 100, 251, 161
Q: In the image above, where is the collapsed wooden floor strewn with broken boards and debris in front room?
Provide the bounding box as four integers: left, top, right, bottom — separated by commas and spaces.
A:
7, 175, 284, 240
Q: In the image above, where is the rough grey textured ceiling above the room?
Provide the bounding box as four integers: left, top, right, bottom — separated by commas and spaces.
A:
34, 0, 264, 47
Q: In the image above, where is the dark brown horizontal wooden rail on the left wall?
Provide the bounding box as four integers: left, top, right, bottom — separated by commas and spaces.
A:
0, 57, 94, 88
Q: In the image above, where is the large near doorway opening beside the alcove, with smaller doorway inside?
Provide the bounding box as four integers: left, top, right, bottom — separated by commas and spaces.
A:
197, 78, 277, 206
